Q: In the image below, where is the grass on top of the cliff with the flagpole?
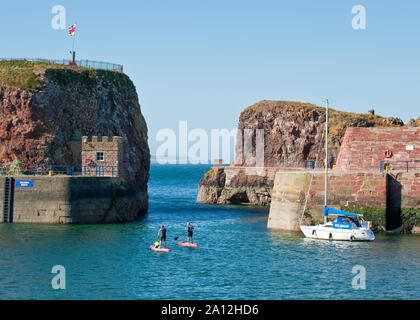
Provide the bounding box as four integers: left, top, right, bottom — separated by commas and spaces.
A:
0, 60, 132, 90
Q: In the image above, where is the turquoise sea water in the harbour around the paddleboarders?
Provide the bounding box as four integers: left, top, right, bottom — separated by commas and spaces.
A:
0, 165, 420, 299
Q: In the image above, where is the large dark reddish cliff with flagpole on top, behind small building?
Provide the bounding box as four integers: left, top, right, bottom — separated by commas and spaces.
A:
0, 61, 150, 218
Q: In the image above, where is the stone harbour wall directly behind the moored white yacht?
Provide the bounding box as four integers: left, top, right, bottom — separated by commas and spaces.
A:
268, 170, 420, 232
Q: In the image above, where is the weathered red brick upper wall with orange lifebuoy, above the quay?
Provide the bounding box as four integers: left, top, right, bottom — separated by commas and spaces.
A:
336, 127, 420, 170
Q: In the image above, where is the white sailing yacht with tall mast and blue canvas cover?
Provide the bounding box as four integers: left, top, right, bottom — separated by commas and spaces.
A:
300, 100, 375, 241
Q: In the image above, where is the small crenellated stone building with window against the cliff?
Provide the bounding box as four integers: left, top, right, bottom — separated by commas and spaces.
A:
82, 136, 123, 177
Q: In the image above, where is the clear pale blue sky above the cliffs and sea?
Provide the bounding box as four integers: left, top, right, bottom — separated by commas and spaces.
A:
0, 0, 420, 154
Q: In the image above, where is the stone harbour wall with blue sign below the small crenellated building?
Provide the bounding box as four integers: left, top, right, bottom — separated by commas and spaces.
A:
0, 176, 147, 224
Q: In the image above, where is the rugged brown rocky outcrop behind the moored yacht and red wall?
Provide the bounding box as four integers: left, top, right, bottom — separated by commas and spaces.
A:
197, 100, 404, 206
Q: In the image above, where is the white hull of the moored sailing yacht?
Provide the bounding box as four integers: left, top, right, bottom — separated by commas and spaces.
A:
300, 225, 375, 241
